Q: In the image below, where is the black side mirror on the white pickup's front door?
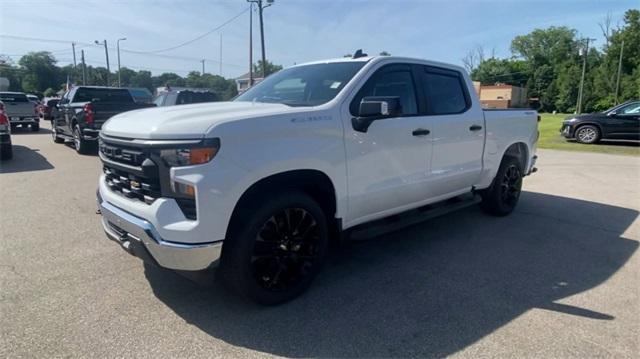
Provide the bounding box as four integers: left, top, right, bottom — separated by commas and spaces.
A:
351, 96, 402, 132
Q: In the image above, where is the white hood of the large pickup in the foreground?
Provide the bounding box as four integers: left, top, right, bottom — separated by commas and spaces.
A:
101, 101, 301, 140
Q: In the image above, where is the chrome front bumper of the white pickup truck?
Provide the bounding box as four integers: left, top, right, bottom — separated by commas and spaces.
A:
98, 195, 222, 271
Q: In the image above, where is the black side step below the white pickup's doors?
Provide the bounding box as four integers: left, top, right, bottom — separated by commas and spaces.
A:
345, 193, 482, 240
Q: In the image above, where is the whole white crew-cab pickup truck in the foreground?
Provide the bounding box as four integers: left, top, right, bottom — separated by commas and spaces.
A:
97, 56, 538, 304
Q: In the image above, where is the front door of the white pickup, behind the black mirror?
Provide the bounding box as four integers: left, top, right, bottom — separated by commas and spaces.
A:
342, 64, 431, 221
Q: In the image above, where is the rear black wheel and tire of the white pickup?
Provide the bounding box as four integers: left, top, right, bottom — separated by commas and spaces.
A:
480, 156, 523, 216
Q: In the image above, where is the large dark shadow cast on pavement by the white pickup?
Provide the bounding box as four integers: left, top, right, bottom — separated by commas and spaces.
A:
145, 192, 638, 357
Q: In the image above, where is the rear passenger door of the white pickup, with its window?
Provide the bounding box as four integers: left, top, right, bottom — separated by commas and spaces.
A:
421, 66, 485, 197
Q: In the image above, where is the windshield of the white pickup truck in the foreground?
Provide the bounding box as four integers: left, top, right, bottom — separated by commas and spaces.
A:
234, 61, 365, 106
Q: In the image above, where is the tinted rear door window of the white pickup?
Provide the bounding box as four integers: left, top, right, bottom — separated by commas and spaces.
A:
422, 67, 469, 115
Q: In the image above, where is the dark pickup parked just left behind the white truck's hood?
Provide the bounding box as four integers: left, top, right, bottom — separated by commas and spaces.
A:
51, 86, 155, 154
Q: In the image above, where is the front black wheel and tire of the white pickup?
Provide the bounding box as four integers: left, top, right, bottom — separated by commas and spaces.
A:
221, 191, 329, 305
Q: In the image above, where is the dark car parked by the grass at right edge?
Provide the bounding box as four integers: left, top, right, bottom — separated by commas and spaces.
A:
560, 100, 640, 144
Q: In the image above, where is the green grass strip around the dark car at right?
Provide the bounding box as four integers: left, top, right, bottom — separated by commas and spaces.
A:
538, 113, 640, 156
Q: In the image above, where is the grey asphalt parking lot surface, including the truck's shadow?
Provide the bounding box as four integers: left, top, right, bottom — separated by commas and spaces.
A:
0, 124, 640, 358
